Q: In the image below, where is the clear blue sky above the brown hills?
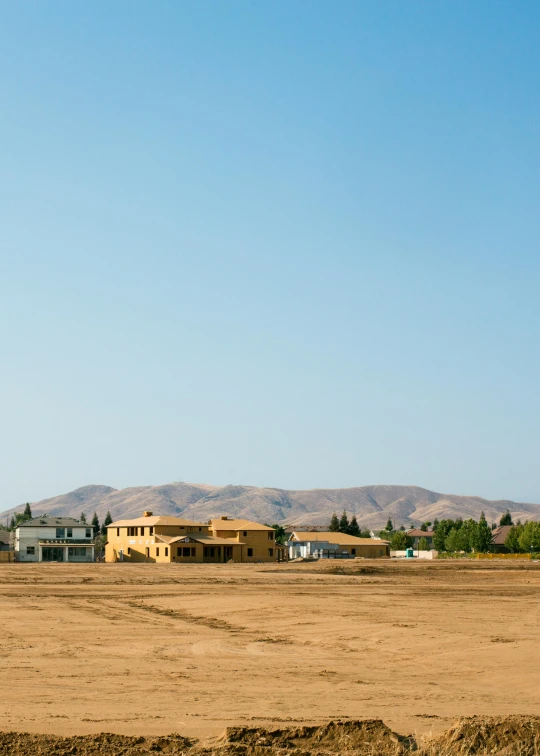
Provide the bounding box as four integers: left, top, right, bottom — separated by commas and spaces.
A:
0, 0, 540, 509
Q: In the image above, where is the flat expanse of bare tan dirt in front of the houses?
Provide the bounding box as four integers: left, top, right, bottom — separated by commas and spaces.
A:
0, 560, 540, 752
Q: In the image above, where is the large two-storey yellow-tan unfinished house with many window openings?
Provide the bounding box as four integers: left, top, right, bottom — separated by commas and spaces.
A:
105, 512, 285, 564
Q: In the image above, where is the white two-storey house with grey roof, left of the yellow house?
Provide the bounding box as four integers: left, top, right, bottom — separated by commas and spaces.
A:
15, 517, 94, 562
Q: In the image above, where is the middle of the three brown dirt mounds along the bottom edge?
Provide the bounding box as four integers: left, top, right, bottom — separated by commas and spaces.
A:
207, 719, 408, 756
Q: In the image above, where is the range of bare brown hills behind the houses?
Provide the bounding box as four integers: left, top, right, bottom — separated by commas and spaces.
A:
0, 483, 540, 529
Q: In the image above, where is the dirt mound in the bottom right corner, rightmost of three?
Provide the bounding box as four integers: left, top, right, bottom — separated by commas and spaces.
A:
421, 716, 540, 756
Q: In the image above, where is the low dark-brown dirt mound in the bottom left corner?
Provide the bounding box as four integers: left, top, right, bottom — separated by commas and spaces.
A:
0, 732, 194, 756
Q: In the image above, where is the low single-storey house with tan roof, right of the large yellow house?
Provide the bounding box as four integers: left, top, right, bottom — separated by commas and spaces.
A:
287, 530, 390, 559
